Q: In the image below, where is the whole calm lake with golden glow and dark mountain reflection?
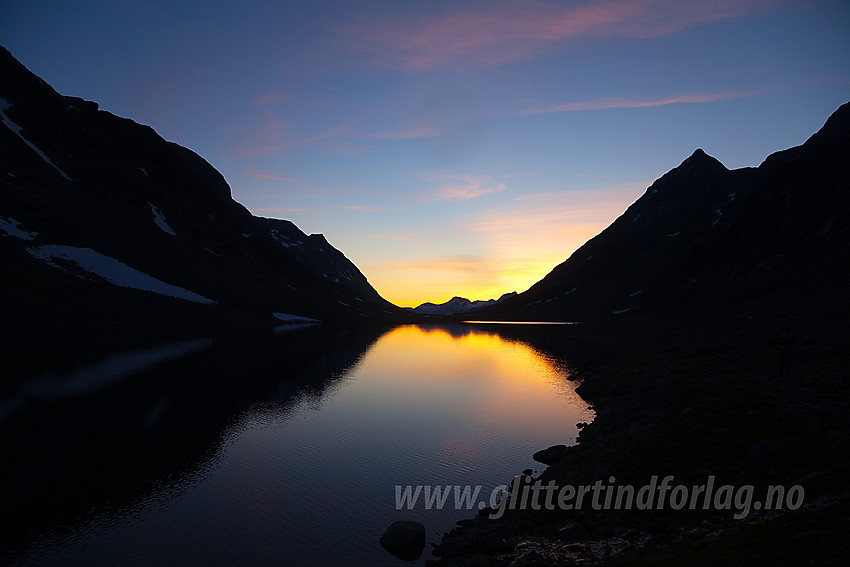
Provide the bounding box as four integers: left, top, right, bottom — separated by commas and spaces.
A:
0, 324, 593, 567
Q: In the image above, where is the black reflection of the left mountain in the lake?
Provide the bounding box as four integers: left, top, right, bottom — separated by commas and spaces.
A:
0, 325, 381, 560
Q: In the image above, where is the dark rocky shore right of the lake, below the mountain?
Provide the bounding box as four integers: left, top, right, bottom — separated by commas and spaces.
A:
426, 306, 850, 566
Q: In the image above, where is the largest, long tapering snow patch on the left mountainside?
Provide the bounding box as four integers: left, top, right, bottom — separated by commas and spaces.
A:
27, 244, 215, 304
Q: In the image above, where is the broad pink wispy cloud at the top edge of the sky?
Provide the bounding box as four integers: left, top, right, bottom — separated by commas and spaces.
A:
343, 0, 799, 71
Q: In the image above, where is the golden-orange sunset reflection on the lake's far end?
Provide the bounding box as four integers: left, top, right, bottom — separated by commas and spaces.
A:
348, 325, 593, 443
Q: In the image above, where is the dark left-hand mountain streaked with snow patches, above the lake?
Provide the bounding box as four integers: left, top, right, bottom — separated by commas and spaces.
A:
0, 48, 404, 330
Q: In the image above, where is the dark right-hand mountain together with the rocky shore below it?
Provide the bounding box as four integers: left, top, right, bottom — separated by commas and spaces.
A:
427, 104, 850, 567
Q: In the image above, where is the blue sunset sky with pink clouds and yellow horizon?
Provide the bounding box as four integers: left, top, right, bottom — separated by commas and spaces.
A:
0, 0, 850, 306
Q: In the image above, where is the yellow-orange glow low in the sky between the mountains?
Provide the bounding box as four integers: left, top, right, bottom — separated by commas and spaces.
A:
355, 181, 650, 307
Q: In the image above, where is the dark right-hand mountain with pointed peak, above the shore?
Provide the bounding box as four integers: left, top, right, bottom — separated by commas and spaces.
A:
476, 103, 850, 320
